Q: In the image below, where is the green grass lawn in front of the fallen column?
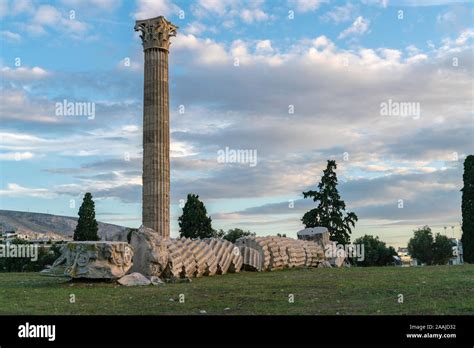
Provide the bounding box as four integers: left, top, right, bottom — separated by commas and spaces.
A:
0, 265, 474, 315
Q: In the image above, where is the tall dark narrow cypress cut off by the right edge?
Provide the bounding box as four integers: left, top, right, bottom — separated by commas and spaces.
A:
461, 155, 474, 263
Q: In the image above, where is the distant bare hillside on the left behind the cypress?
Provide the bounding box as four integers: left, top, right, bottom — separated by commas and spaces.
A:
0, 210, 127, 241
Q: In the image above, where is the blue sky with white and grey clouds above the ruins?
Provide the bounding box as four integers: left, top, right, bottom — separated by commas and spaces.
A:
0, 0, 474, 246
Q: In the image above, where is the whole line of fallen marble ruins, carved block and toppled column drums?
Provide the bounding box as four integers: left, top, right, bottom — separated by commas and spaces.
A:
43, 226, 345, 280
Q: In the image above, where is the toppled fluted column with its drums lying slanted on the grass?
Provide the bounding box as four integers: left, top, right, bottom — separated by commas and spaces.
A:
126, 226, 342, 278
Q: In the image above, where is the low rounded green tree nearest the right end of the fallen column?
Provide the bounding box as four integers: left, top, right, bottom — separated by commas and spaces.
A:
353, 234, 397, 267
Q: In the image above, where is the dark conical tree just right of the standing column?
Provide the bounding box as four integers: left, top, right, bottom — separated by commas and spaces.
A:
178, 193, 215, 238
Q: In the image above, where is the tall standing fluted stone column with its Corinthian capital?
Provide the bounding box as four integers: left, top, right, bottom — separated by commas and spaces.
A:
135, 16, 178, 237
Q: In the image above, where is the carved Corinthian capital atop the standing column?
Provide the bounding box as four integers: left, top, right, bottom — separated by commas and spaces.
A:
135, 16, 178, 51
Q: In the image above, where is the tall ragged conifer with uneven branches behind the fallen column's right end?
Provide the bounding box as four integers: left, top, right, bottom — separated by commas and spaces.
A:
301, 160, 358, 244
